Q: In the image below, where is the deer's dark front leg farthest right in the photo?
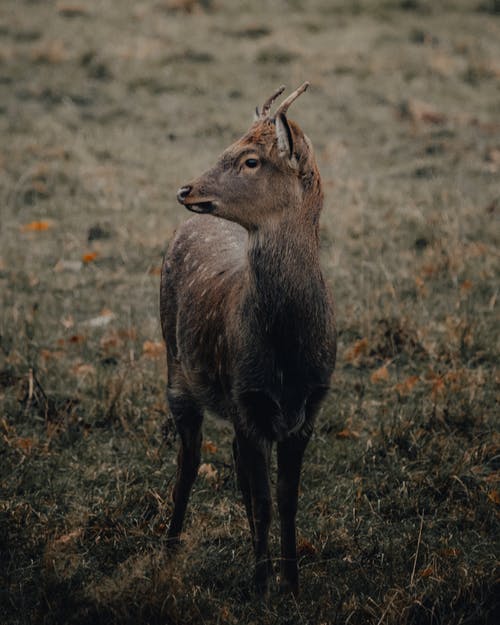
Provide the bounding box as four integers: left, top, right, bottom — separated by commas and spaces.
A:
277, 436, 309, 595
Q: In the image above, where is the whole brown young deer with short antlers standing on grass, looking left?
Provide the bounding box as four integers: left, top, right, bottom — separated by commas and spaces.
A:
160, 83, 336, 594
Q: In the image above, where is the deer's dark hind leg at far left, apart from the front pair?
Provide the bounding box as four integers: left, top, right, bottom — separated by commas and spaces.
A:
167, 393, 203, 544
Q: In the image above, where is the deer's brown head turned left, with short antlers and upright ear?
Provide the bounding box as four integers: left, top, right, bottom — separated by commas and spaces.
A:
177, 83, 319, 230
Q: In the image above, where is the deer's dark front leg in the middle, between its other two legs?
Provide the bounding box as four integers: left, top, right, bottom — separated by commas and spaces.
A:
235, 433, 272, 595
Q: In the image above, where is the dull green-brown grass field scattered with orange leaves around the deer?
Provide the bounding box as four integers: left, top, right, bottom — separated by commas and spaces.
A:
0, 0, 500, 625
